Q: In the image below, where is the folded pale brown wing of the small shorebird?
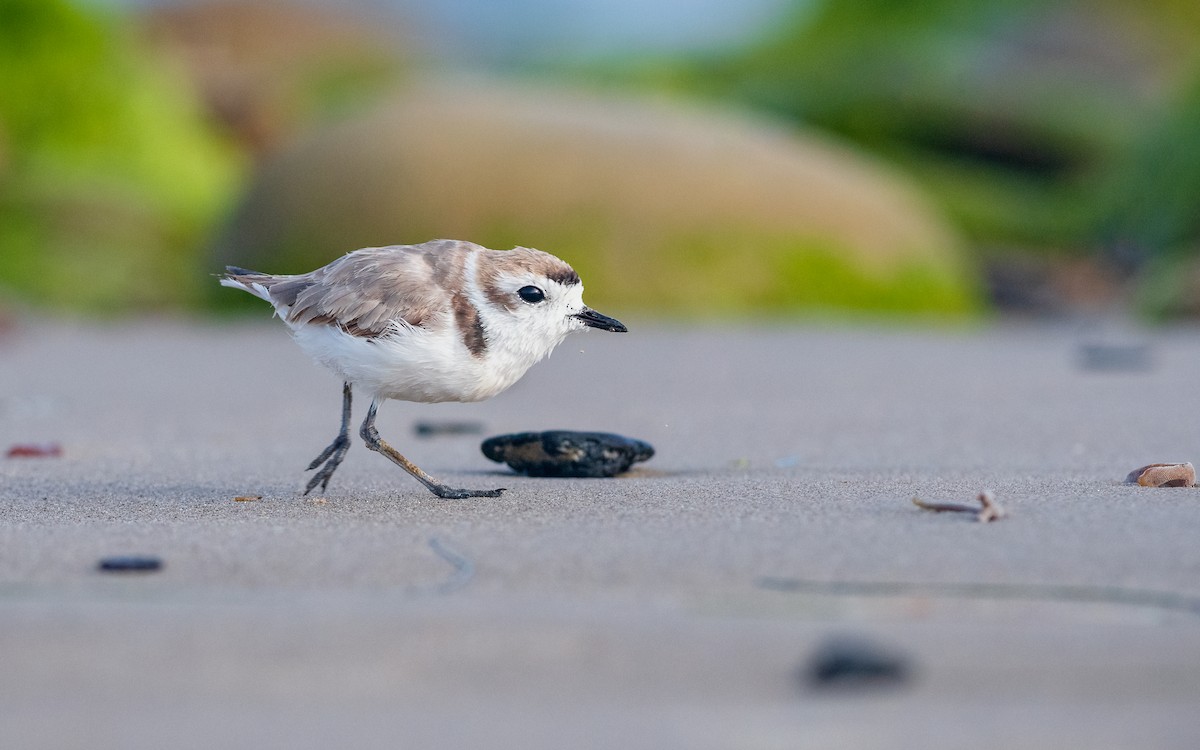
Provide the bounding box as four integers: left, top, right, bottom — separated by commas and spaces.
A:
268, 240, 475, 337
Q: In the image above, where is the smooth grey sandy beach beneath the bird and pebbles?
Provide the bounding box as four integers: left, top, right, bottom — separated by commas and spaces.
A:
0, 320, 1200, 749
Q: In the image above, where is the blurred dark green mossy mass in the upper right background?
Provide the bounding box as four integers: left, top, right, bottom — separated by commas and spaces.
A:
589, 0, 1200, 265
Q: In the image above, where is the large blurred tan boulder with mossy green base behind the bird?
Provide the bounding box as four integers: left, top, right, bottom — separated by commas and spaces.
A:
212, 82, 976, 314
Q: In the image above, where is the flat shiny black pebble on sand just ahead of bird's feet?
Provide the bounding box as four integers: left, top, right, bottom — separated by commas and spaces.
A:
480, 430, 654, 478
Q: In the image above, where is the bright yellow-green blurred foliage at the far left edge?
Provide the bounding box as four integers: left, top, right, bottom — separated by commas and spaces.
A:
0, 0, 240, 311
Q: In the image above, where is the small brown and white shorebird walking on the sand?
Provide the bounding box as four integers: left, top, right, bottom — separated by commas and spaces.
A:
220, 240, 629, 499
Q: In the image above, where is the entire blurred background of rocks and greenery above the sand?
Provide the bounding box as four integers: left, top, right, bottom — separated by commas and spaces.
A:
0, 0, 1200, 319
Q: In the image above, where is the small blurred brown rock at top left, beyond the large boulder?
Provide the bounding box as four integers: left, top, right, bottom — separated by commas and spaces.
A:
143, 0, 418, 152
